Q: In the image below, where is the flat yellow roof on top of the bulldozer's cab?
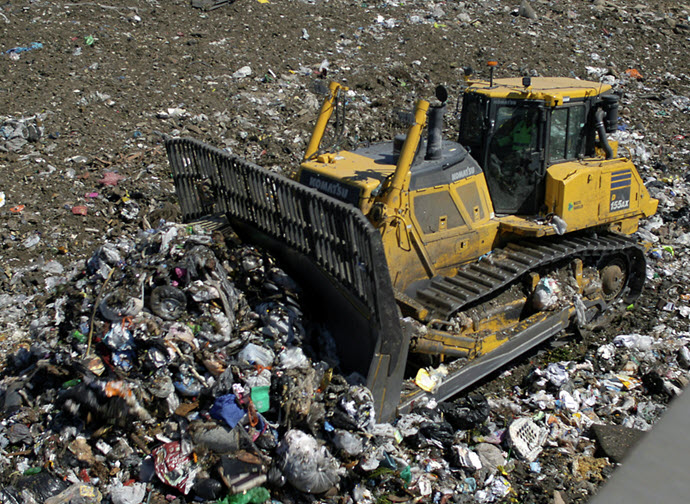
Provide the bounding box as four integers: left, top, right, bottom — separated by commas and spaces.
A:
465, 77, 611, 106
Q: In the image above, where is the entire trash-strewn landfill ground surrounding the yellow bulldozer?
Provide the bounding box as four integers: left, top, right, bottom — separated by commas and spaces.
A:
0, 0, 690, 504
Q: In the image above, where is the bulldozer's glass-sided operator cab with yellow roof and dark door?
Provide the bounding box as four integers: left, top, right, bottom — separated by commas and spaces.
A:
458, 78, 617, 215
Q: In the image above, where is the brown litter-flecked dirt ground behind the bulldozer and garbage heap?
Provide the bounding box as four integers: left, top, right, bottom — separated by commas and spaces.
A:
0, 0, 690, 502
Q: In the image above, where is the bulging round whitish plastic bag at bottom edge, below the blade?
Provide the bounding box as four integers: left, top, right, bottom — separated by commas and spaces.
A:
276, 430, 340, 494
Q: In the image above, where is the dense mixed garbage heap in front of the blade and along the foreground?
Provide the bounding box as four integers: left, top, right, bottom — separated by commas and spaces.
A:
0, 222, 690, 504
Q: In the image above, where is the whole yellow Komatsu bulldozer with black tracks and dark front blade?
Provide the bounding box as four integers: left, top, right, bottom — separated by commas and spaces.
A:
166, 66, 658, 421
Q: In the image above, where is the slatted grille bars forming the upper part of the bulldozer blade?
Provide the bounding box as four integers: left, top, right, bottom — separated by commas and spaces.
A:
166, 138, 387, 309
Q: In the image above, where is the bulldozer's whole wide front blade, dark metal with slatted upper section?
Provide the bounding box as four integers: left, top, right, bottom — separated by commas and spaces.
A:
165, 138, 409, 421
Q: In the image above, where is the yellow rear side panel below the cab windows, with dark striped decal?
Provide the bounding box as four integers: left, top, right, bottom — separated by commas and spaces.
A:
545, 158, 657, 231
